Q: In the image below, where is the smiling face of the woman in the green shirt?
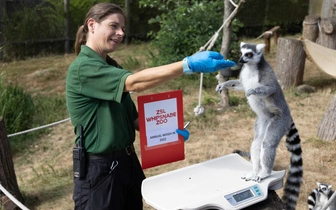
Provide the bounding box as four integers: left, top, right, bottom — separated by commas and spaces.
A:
87, 13, 125, 57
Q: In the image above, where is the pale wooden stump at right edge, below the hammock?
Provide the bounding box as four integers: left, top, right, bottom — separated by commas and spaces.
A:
317, 96, 336, 141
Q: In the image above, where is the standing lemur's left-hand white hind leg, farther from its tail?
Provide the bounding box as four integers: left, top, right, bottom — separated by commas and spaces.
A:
241, 117, 265, 181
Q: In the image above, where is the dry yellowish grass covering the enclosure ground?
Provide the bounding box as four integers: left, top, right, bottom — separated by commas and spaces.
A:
0, 40, 336, 210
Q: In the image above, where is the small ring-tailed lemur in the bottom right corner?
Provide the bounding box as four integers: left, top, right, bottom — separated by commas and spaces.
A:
308, 182, 336, 210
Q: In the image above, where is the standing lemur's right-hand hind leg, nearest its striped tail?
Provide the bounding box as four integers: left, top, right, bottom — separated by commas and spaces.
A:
255, 116, 287, 181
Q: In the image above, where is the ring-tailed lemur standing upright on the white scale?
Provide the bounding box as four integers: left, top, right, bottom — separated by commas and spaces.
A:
216, 42, 303, 210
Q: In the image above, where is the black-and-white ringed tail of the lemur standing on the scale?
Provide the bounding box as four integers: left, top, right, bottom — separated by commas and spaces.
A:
283, 123, 303, 210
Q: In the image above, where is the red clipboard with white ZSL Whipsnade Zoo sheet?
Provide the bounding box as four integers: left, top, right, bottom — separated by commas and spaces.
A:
138, 90, 184, 169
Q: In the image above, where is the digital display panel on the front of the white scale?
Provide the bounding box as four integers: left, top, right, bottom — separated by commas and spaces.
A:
224, 184, 263, 206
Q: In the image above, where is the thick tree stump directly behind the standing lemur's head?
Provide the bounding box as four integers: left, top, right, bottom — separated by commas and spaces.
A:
274, 38, 306, 90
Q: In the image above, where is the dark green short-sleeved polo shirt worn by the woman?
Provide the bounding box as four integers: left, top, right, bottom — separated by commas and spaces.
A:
66, 45, 138, 154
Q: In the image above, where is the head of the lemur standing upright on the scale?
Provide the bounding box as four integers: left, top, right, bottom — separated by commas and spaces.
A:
239, 42, 265, 64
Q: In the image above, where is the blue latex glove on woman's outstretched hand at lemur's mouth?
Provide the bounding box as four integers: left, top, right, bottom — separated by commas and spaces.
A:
183, 51, 236, 74
